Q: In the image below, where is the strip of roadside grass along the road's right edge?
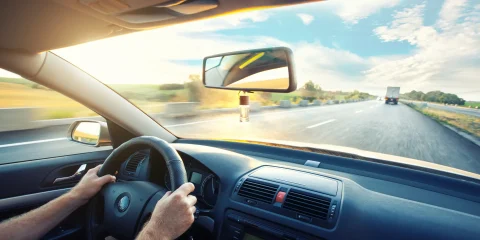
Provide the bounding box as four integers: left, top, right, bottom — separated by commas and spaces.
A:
407, 104, 480, 138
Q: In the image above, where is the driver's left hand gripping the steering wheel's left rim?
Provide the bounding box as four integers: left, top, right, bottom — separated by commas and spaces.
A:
69, 165, 115, 203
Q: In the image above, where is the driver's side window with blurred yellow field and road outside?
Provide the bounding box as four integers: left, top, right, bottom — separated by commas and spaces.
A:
0, 69, 109, 161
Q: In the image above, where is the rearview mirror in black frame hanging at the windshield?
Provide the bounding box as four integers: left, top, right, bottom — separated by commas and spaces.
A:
203, 47, 297, 92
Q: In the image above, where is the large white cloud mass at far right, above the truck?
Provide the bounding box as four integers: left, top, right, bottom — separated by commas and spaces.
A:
365, 0, 480, 98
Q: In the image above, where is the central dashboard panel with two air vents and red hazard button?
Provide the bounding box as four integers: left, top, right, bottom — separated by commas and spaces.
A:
220, 166, 343, 240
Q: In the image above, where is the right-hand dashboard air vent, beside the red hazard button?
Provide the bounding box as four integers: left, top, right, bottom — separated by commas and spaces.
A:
283, 189, 331, 219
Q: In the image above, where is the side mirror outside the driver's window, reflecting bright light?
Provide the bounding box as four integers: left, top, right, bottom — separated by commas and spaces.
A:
68, 120, 112, 147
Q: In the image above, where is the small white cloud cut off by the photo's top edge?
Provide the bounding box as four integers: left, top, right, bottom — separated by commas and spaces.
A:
319, 0, 400, 24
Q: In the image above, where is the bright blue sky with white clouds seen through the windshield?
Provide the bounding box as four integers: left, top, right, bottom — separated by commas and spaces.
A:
0, 0, 480, 101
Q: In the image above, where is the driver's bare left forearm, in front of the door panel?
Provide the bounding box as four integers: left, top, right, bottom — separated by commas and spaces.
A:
0, 192, 85, 239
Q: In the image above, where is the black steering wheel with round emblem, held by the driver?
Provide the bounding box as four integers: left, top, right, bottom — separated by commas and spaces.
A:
86, 136, 187, 240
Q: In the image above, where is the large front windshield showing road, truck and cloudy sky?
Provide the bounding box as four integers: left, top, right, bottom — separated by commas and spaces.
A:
4, 0, 480, 173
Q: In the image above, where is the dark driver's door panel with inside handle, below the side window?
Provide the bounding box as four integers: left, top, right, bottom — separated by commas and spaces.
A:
0, 149, 112, 239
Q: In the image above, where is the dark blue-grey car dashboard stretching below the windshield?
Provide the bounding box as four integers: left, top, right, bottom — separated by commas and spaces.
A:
119, 140, 480, 240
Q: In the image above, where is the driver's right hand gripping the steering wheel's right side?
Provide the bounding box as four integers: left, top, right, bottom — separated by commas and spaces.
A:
137, 183, 197, 240
